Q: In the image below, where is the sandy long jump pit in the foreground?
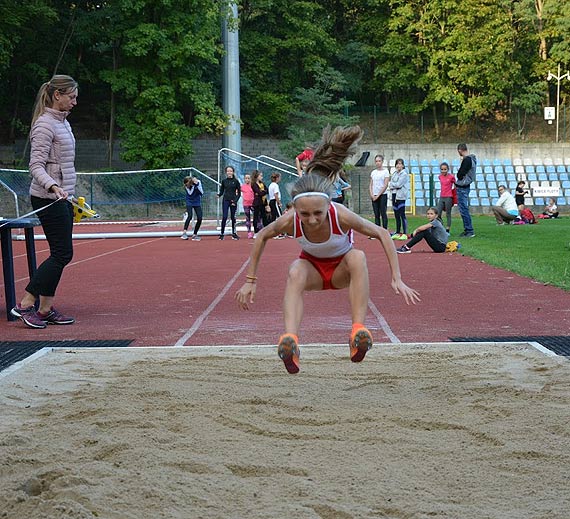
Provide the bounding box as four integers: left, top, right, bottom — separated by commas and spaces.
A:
0, 344, 570, 519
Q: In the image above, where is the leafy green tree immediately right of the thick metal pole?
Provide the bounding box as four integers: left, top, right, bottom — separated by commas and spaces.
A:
240, 0, 337, 133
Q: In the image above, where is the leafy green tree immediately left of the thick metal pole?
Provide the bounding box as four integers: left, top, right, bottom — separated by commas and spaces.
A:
96, 0, 225, 167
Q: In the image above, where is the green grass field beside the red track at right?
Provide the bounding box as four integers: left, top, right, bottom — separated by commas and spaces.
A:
404, 215, 570, 291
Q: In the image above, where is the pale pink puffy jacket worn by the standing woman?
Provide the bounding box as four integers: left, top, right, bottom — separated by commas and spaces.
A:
30, 108, 76, 200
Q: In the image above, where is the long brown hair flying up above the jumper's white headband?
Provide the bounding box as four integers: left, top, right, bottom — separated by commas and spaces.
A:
291, 126, 362, 198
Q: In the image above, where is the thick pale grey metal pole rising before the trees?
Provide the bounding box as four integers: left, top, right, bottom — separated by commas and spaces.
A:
222, 1, 241, 153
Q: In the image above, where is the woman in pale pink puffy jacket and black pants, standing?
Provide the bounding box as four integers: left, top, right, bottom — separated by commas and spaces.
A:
11, 75, 77, 328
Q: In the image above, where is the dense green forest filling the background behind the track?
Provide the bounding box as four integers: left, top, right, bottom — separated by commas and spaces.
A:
0, 0, 570, 167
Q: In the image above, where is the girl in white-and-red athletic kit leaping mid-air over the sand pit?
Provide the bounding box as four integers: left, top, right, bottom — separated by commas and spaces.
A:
235, 126, 420, 373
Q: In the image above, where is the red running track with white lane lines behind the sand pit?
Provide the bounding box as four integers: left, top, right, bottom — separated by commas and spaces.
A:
0, 226, 570, 346
